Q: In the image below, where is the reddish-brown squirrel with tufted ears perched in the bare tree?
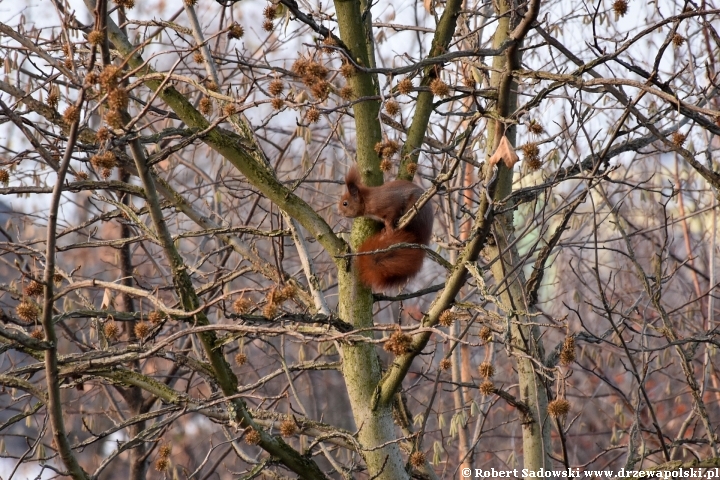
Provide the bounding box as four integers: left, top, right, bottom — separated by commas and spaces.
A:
338, 165, 433, 290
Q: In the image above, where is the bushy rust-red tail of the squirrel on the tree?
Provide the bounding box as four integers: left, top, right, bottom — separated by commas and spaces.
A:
355, 230, 425, 290
